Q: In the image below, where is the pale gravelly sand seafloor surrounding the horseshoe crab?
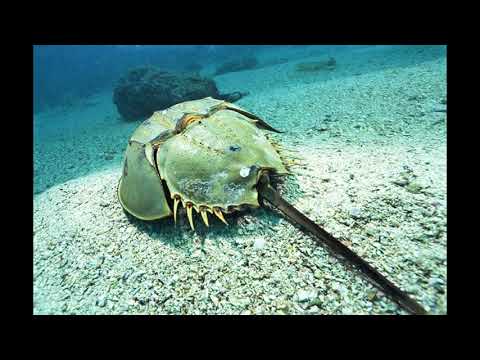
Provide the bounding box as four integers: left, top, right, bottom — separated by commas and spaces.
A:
33, 47, 447, 314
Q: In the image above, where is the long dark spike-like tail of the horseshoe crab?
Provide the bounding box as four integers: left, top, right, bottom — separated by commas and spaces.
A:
258, 172, 427, 315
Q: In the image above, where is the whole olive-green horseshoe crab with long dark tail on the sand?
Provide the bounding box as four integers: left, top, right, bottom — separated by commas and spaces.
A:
117, 97, 426, 314
